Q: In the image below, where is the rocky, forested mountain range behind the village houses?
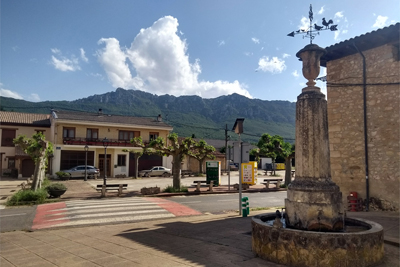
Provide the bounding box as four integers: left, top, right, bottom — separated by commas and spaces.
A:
0, 88, 296, 142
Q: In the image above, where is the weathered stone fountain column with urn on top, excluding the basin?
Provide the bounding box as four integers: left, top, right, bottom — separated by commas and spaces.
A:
285, 44, 344, 231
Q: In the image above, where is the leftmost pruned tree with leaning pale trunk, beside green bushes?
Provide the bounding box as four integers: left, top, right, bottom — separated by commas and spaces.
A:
13, 132, 53, 191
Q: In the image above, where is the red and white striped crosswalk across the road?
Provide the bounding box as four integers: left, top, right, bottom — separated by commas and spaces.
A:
32, 197, 201, 230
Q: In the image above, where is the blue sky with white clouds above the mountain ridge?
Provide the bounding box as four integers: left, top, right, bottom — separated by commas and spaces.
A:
0, 0, 400, 102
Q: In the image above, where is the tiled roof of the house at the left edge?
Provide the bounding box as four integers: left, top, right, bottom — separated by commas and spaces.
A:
0, 111, 51, 127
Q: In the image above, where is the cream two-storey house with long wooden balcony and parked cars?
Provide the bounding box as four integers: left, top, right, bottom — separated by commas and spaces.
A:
50, 109, 172, 177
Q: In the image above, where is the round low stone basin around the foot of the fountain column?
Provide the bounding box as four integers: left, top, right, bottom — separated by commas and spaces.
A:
251, 213, 384, 267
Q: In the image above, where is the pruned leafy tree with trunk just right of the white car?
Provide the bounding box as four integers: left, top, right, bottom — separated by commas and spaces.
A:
131, 133, 196, 190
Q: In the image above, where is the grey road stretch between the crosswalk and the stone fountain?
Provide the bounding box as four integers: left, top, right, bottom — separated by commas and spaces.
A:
168, 191, 286, 213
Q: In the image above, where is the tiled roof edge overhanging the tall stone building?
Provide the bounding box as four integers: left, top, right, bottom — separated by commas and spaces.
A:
321, 23, 400, 67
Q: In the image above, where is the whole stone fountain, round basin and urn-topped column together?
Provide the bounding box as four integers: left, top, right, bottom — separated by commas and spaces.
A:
252, 44, 384, 266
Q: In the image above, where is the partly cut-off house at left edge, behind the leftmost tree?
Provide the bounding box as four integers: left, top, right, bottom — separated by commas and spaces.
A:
0, 111, 51, 178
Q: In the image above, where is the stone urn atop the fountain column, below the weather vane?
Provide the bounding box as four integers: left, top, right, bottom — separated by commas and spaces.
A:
296, 44, 326, 91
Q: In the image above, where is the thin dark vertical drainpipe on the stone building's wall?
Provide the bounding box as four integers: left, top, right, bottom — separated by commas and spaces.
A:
353, 43, 369, 211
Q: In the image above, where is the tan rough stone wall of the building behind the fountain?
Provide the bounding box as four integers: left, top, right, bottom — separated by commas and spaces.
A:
327, 44, 400, 210
